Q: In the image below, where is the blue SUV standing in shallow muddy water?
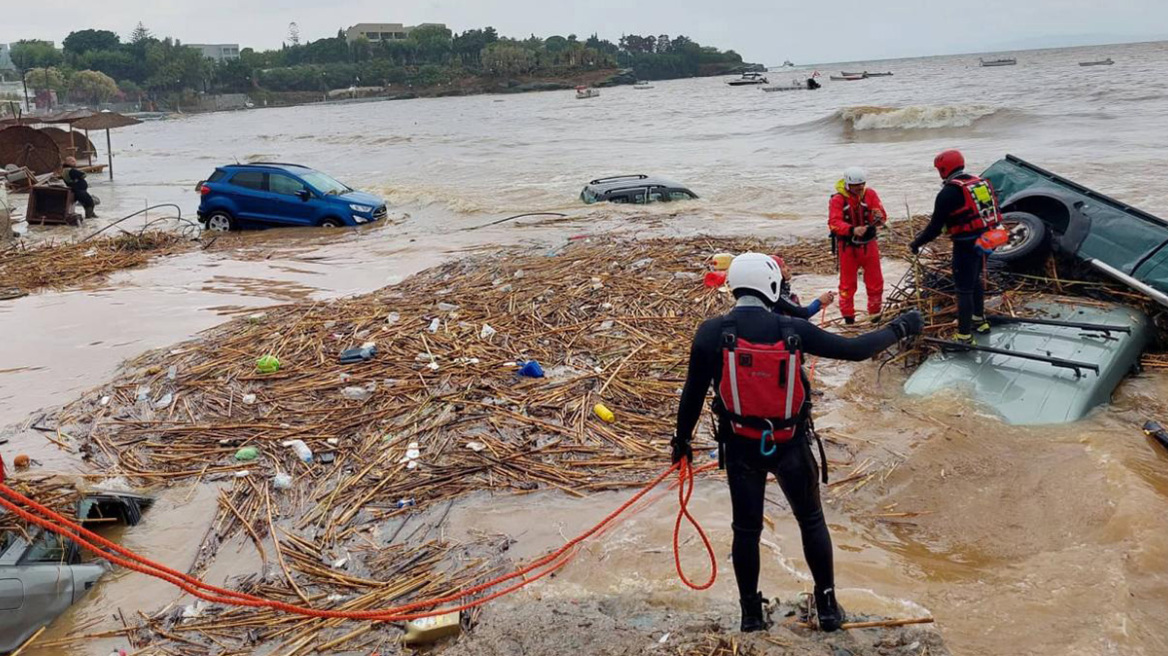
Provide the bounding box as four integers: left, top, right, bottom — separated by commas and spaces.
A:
199, 162, 388, 232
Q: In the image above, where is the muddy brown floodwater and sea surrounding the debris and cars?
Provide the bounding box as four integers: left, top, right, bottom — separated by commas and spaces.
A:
0, 43, 1168, 656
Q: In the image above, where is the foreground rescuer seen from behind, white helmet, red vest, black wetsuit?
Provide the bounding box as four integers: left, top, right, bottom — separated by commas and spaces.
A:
673, 253, 924, 631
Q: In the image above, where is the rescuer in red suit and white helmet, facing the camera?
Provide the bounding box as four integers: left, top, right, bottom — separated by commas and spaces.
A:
827, 167, 888, 324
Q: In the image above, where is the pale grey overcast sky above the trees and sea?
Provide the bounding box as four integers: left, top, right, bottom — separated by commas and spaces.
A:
9, 0, 1168, 65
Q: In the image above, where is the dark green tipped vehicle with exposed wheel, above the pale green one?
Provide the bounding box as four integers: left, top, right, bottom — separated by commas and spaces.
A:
982, 155, 1168, 306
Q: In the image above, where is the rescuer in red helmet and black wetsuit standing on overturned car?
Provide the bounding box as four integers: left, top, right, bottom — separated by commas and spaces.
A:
909, 151, 1001, 344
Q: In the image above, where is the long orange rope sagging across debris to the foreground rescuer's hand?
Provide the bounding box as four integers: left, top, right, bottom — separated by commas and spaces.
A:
0, 460, 717, 622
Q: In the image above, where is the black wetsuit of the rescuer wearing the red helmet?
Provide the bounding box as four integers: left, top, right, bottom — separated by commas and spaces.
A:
912, 173, 986, 335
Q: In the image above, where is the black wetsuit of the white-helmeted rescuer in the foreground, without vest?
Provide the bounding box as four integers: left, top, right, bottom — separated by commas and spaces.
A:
677, 305, 897, 599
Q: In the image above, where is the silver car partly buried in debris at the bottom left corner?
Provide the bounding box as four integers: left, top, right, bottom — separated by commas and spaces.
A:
0, 493, 153, 654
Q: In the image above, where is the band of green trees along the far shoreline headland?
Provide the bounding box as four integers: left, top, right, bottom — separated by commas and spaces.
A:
0, 23, 762, 112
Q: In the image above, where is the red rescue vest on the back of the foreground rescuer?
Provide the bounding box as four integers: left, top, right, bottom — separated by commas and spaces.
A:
717, 323, 809, 448
